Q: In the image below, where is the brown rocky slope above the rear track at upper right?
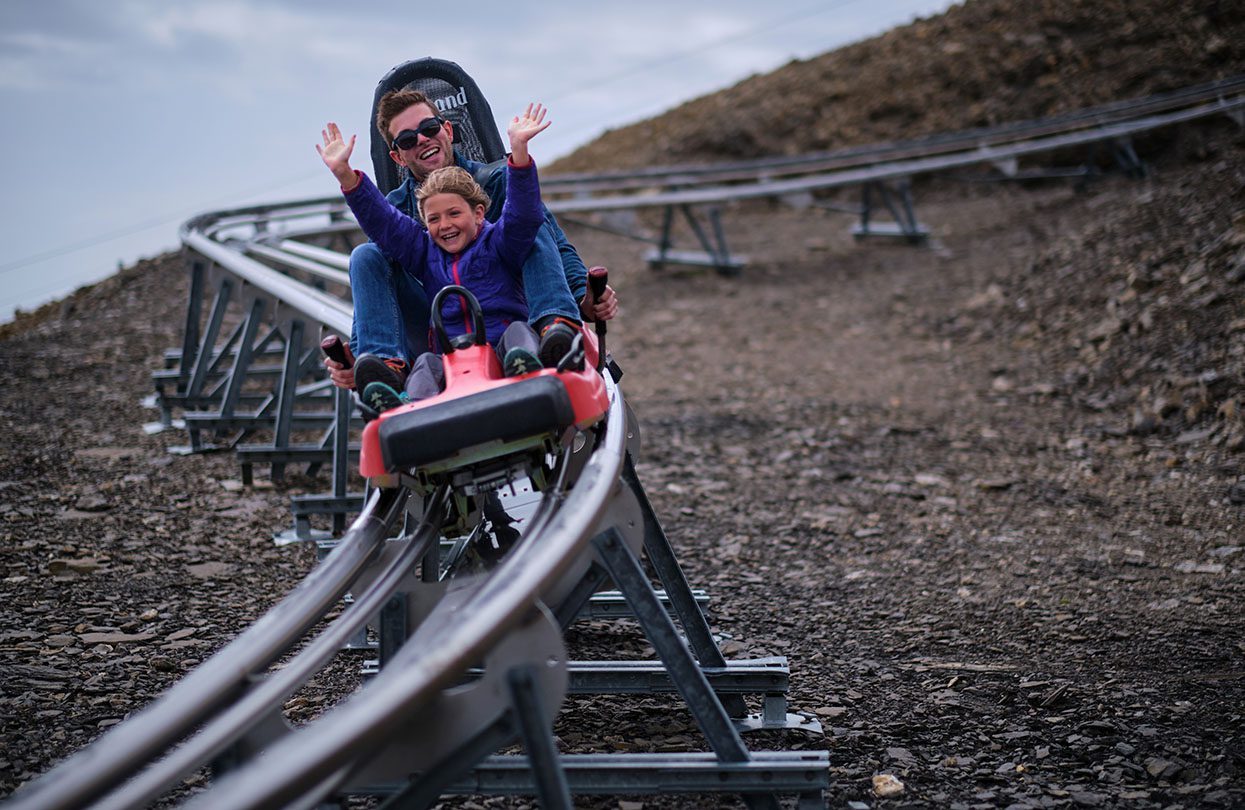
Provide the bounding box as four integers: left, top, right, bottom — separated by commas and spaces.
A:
552, 0, 1245, 172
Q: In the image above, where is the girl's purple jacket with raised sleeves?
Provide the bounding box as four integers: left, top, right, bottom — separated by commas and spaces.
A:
346, 163, 544, 345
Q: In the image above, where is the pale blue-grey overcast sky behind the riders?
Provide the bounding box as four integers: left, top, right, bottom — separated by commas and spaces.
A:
0, 0, 951, 321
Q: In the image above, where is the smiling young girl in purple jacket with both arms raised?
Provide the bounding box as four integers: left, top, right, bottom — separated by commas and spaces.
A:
316, 105, 575, 411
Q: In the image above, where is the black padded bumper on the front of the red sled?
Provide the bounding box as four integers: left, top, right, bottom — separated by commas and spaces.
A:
380, 376, 575, 470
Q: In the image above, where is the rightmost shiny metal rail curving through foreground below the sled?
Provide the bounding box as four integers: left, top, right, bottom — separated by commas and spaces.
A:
190, 381, 626, 809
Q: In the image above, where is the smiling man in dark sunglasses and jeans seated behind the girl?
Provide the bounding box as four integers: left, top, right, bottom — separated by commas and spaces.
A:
325, 90, 618, 391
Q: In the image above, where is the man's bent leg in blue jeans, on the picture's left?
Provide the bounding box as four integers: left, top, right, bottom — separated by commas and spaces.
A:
350, 241, 428, 362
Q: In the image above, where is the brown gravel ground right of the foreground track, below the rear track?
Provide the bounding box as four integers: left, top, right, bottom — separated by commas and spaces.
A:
562, 130, 1245, 808
